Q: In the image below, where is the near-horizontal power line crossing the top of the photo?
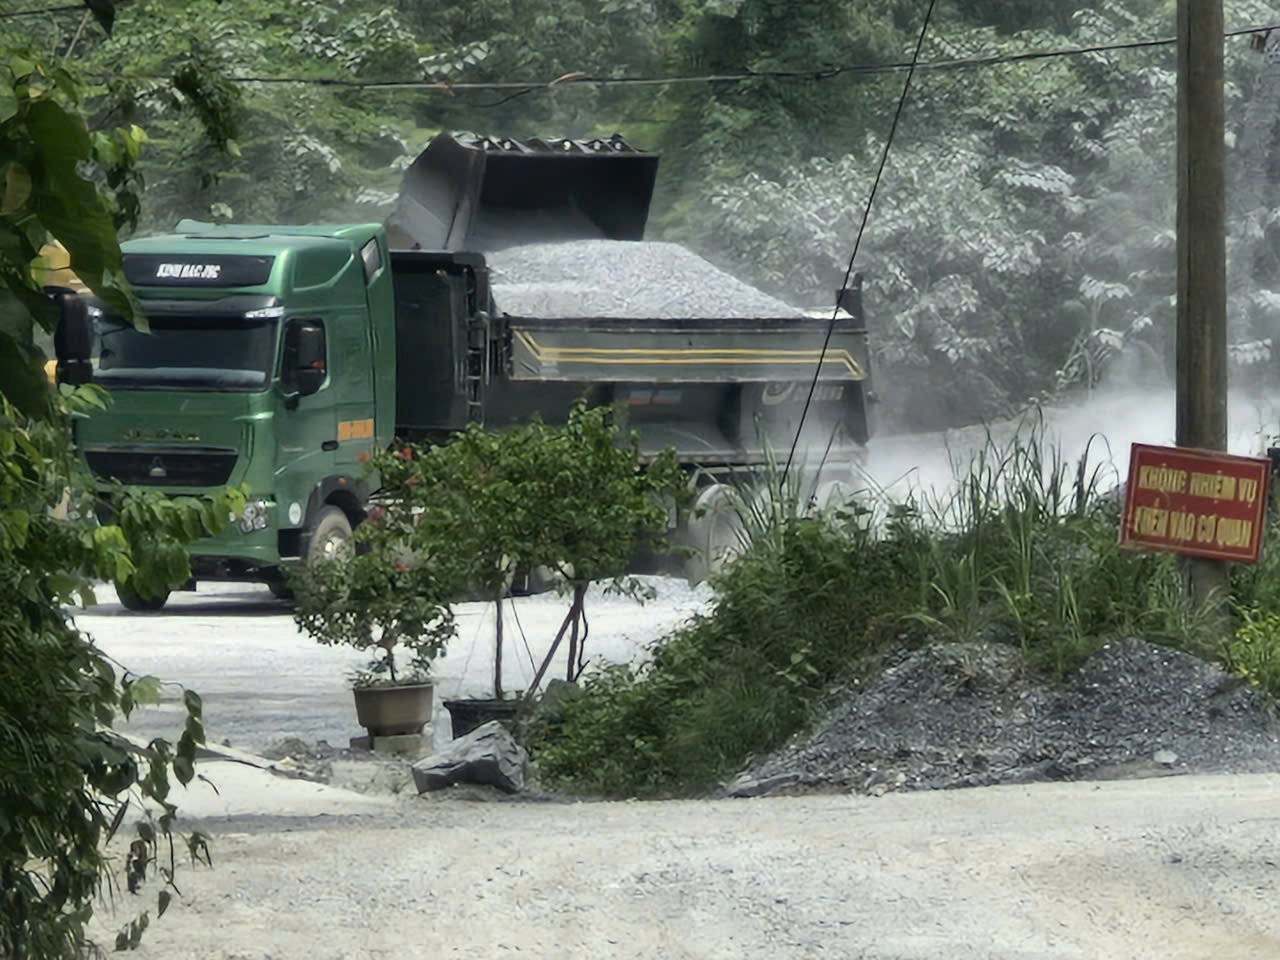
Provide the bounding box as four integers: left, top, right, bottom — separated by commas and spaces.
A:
94, 21, 1280, 93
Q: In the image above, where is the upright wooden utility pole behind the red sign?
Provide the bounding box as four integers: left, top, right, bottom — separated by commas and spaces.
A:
1178, 0, 1228, 607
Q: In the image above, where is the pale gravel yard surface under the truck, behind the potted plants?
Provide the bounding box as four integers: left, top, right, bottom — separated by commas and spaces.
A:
76, 577, 710, 751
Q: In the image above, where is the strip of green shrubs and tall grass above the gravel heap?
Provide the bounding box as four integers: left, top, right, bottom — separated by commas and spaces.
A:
531, 419, 1280, 795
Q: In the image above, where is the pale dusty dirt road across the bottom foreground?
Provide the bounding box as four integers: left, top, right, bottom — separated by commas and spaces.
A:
92, 776, 1280, 960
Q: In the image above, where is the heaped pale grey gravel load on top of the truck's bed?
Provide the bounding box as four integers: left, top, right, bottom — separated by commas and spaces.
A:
486, 239, 805, 320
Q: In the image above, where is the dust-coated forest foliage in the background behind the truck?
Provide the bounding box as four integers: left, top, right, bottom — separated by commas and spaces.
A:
17, 0, 1280, 426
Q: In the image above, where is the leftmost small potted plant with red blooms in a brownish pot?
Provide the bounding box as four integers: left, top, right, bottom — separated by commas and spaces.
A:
288, 447, 465, 737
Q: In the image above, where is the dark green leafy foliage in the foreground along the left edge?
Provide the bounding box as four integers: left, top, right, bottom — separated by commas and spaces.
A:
0, 45, 241, 960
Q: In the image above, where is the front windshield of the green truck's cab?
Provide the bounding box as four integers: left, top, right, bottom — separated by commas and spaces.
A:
93, 316, 275, 392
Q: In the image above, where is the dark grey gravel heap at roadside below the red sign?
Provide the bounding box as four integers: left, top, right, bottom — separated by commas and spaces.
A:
728, 640, 1280, 796
